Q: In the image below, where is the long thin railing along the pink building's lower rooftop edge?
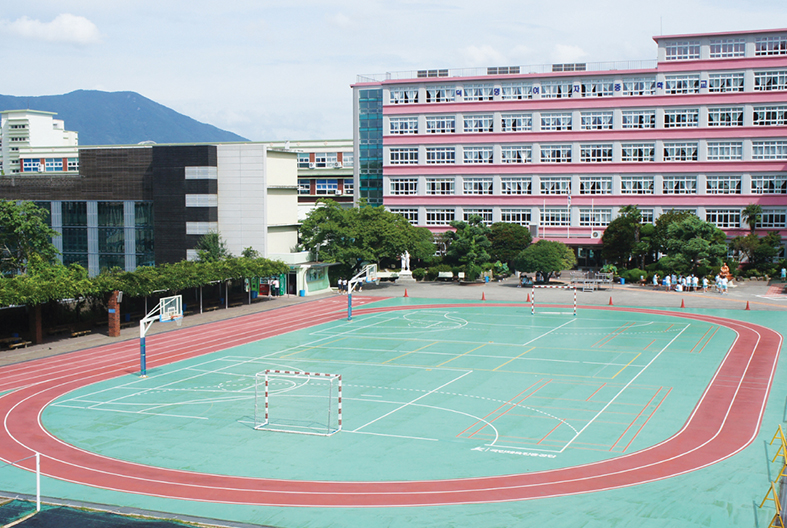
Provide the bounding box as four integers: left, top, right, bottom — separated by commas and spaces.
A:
357, 59, 658, 83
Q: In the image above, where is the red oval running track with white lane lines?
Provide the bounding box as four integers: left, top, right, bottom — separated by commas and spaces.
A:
0, 297, 782, 507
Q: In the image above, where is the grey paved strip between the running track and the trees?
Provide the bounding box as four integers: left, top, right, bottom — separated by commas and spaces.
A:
0, 278, 787, 366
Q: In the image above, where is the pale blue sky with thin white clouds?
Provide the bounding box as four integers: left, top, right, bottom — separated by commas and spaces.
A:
0, 0, 787, 141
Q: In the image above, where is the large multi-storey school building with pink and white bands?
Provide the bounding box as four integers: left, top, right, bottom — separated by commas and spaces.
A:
353, 29, 787, 262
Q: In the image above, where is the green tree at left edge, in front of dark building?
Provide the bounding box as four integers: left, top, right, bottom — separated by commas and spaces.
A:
0, 200, 58, 274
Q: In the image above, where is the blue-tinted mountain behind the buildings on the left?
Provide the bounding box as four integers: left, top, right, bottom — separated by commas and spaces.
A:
0, 90, 248, 145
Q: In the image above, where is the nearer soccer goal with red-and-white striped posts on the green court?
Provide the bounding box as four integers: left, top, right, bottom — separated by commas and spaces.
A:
254, 370, 342, 436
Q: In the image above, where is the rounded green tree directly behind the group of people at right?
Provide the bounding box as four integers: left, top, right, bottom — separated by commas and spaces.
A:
665, 215, 727, 271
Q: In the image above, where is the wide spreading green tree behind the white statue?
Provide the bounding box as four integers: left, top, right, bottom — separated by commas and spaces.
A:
300, 200, 435, 272
